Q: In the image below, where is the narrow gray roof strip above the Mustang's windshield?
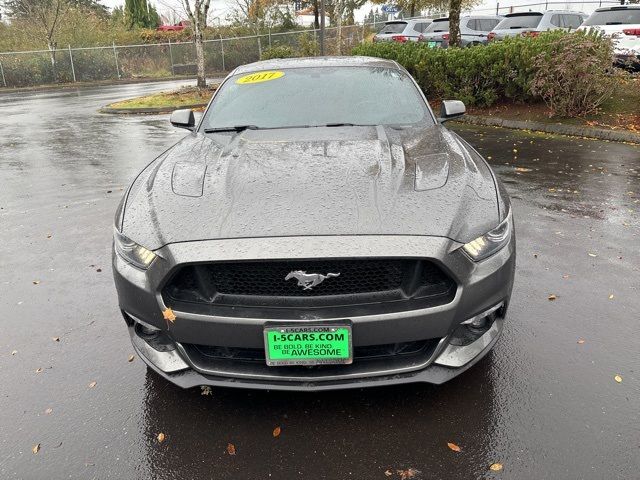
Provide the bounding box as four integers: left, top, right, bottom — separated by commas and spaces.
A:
232, 56, 401, 75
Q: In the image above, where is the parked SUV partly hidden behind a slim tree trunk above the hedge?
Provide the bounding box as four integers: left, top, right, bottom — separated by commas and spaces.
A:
418, 15, 504, 48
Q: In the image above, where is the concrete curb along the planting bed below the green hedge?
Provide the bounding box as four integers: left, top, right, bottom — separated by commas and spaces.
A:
456, 115, 640, 144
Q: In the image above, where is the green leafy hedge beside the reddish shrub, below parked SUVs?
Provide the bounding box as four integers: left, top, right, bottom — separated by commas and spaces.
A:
352, 31, 611, 106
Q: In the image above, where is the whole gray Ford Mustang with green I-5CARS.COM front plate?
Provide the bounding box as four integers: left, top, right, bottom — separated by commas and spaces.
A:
113, 57, 515, 390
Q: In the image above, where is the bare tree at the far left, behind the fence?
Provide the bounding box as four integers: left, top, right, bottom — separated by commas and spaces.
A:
5, 0, 71, 82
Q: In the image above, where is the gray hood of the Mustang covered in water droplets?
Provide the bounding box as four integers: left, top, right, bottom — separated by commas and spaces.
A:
122, 125, 499, 249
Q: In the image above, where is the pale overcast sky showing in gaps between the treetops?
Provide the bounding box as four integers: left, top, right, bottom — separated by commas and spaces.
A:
100, 0, 598, 21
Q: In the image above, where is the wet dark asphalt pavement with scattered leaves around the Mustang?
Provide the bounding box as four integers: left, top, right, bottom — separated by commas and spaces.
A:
0, 80, 640, 480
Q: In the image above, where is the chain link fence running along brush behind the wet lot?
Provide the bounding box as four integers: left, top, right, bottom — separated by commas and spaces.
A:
0, 23, 384, 88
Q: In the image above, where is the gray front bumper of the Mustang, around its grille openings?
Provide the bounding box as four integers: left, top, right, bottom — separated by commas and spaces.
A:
113, 236, 515, 390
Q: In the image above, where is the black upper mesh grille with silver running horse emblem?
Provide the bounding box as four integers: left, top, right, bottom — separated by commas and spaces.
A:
163, 258, 455, 308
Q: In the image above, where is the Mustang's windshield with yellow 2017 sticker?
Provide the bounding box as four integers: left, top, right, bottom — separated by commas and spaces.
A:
202, 67, 433, 130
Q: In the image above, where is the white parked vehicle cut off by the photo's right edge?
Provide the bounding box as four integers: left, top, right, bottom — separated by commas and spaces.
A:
580, 5, 640, 68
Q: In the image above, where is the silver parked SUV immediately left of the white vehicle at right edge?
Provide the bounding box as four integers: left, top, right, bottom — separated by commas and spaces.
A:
489, 10, 587, 41
